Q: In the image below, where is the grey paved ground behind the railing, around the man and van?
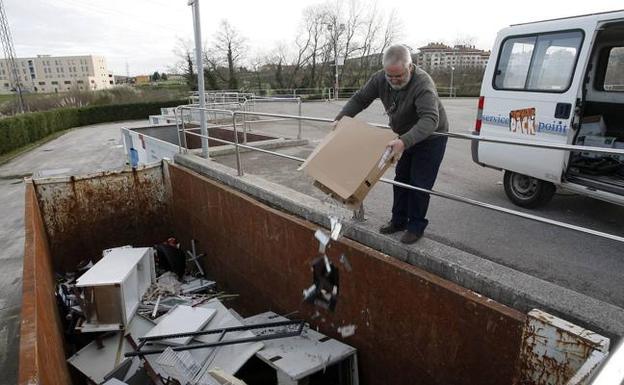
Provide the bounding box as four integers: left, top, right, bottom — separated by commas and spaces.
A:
217, 99, 624, 307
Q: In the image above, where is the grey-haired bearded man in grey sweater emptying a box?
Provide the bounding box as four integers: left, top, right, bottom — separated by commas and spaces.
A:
336, 45, 448, 244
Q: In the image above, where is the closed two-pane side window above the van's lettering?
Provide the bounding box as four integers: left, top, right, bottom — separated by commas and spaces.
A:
494, 31, 583, 92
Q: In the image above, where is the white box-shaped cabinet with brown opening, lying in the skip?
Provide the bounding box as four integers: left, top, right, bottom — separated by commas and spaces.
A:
76, 247, 156, 332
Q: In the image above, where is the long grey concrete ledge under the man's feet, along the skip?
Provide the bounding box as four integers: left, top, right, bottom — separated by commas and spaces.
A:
175, 155, 624, 339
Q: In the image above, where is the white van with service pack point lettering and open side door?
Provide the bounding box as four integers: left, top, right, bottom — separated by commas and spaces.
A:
472, 11, 624, 207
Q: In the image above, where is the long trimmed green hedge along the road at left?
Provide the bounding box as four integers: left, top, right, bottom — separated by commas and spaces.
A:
0, 99, 188, 155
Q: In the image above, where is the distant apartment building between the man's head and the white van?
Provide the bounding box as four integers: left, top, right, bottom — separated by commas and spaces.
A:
416, 43, 490, 70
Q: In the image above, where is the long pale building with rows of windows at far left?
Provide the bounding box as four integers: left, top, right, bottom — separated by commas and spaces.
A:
0, 55, 114, 94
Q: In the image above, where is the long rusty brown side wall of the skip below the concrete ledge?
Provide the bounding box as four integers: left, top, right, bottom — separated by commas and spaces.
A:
169, 165, 525, 384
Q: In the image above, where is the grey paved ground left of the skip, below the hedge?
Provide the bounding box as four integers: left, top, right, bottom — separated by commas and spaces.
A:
0, 121, 147, 384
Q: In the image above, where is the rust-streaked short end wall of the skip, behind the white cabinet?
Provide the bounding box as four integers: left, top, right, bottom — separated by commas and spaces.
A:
34, 165, 171, 272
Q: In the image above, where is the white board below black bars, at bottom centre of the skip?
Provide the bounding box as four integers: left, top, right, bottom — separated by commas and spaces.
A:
245, 312, 357, 381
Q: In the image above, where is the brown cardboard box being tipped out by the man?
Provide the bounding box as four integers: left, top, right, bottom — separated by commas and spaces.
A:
299, 117, 397, 209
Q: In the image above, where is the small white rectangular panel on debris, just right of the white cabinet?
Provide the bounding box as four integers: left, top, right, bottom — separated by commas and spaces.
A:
146, 305, 216, 345
